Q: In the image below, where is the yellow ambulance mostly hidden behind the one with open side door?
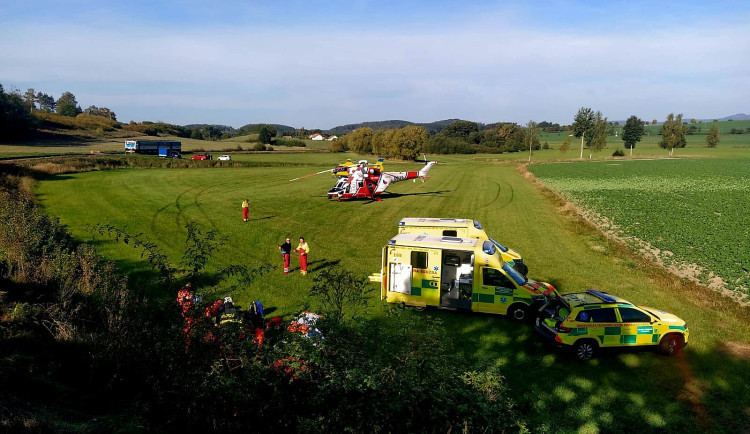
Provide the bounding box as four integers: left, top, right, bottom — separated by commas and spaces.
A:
398, 217, 529, 276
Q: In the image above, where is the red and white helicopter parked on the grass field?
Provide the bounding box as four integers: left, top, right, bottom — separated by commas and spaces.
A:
328, 161, 436, 202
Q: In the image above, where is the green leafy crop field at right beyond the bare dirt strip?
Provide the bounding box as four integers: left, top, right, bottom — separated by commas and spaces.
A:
531, 159, 750, 299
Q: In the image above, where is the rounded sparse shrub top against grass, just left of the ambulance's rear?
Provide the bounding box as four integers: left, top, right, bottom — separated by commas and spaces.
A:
310, 266, 373, 318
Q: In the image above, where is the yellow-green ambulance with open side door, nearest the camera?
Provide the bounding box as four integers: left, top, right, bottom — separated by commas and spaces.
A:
370, 234, 556, 320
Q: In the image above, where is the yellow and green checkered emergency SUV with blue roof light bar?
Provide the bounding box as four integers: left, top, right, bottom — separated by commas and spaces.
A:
536, 289, 688, 360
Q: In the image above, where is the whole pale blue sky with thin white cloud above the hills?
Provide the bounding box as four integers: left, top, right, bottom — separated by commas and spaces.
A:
0, 0, 750, 128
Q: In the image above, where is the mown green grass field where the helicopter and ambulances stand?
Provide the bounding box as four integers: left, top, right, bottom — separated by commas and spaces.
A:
38, 151, 750, 432
